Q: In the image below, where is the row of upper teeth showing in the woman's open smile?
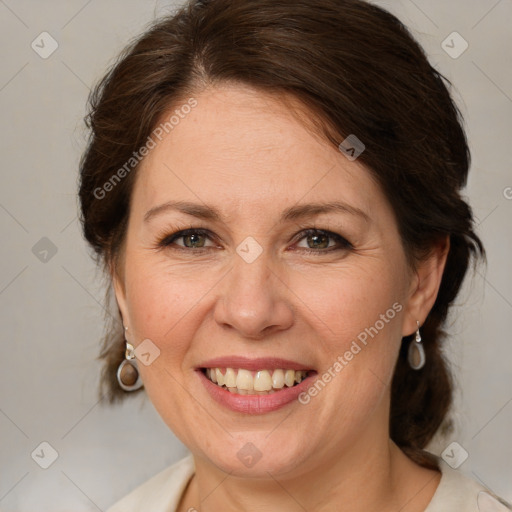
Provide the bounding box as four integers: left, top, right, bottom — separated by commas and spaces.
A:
201, 368, 315, 395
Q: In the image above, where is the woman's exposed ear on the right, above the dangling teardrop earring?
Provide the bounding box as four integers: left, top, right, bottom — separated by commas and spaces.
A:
402, 236, 450, 336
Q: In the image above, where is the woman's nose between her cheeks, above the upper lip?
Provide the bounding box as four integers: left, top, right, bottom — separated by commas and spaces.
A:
214, 251, 294, 340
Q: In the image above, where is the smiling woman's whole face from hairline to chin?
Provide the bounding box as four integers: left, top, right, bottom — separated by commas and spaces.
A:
115, 86, 427, 476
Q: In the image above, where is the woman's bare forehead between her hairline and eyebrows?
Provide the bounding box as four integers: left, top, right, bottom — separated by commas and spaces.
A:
134, 85, 382, 219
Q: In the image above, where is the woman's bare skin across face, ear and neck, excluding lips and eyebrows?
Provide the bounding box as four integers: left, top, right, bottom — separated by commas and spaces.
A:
112, 85, 448, 512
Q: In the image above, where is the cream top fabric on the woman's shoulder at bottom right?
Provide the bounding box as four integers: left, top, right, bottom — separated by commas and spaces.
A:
425, 459, 512, 512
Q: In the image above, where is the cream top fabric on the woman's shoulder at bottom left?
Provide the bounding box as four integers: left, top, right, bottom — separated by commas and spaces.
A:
107, 455, 195, 512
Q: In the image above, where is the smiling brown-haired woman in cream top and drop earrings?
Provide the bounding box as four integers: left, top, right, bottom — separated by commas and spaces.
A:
80, 0, 507, 512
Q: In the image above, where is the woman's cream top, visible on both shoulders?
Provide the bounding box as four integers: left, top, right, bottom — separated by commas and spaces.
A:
107, 455, 512, 512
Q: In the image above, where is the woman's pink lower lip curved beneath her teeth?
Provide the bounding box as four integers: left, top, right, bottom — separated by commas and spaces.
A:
197, 370, 316, 414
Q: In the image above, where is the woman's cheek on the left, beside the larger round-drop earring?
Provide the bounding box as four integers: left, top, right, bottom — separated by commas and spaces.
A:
121, 256, 218, 442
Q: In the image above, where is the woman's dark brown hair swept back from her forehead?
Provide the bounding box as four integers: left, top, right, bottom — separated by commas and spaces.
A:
80, 0, 485, 466
